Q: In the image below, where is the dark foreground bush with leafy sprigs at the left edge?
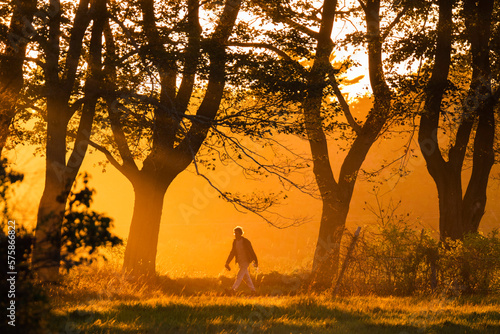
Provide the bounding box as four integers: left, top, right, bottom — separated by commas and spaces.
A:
0, 168, 121, 333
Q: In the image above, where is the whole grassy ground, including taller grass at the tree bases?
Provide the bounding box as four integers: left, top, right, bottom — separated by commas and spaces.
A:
45, 268, 500, 334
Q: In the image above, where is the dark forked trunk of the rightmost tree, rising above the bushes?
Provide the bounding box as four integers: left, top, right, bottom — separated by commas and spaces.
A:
419, 0, 496, 240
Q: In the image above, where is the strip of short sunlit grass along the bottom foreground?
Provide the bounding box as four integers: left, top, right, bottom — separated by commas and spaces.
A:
49, 296, 500, 333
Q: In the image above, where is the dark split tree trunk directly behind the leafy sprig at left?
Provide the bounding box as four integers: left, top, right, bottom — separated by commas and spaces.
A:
32, 0, 106, 282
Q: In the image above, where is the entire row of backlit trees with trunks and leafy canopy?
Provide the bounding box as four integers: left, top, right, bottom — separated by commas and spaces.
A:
0, 0, 500, 282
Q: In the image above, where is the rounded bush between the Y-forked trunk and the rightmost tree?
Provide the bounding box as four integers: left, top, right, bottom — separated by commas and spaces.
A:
341, 221, 436, 295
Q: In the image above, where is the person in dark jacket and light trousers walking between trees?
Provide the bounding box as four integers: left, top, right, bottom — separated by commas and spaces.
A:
226, 226, 259, 292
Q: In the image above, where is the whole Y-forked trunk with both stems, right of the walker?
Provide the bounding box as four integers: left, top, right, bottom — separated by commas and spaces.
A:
304, 0, 391, 287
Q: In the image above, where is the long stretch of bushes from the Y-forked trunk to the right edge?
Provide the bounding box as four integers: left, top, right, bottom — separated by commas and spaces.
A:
340, 222, 500, 295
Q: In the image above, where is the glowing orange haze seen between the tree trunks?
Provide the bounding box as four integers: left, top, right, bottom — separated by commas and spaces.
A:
12, 126, 500, 276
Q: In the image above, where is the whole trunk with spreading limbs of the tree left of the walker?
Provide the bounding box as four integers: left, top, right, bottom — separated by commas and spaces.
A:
103, 0, 241, 276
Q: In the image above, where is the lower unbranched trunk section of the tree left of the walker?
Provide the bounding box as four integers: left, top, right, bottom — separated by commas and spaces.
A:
123, 175, 171, 276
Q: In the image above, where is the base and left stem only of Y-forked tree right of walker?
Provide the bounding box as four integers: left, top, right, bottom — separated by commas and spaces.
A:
303, 0, 340, 287
